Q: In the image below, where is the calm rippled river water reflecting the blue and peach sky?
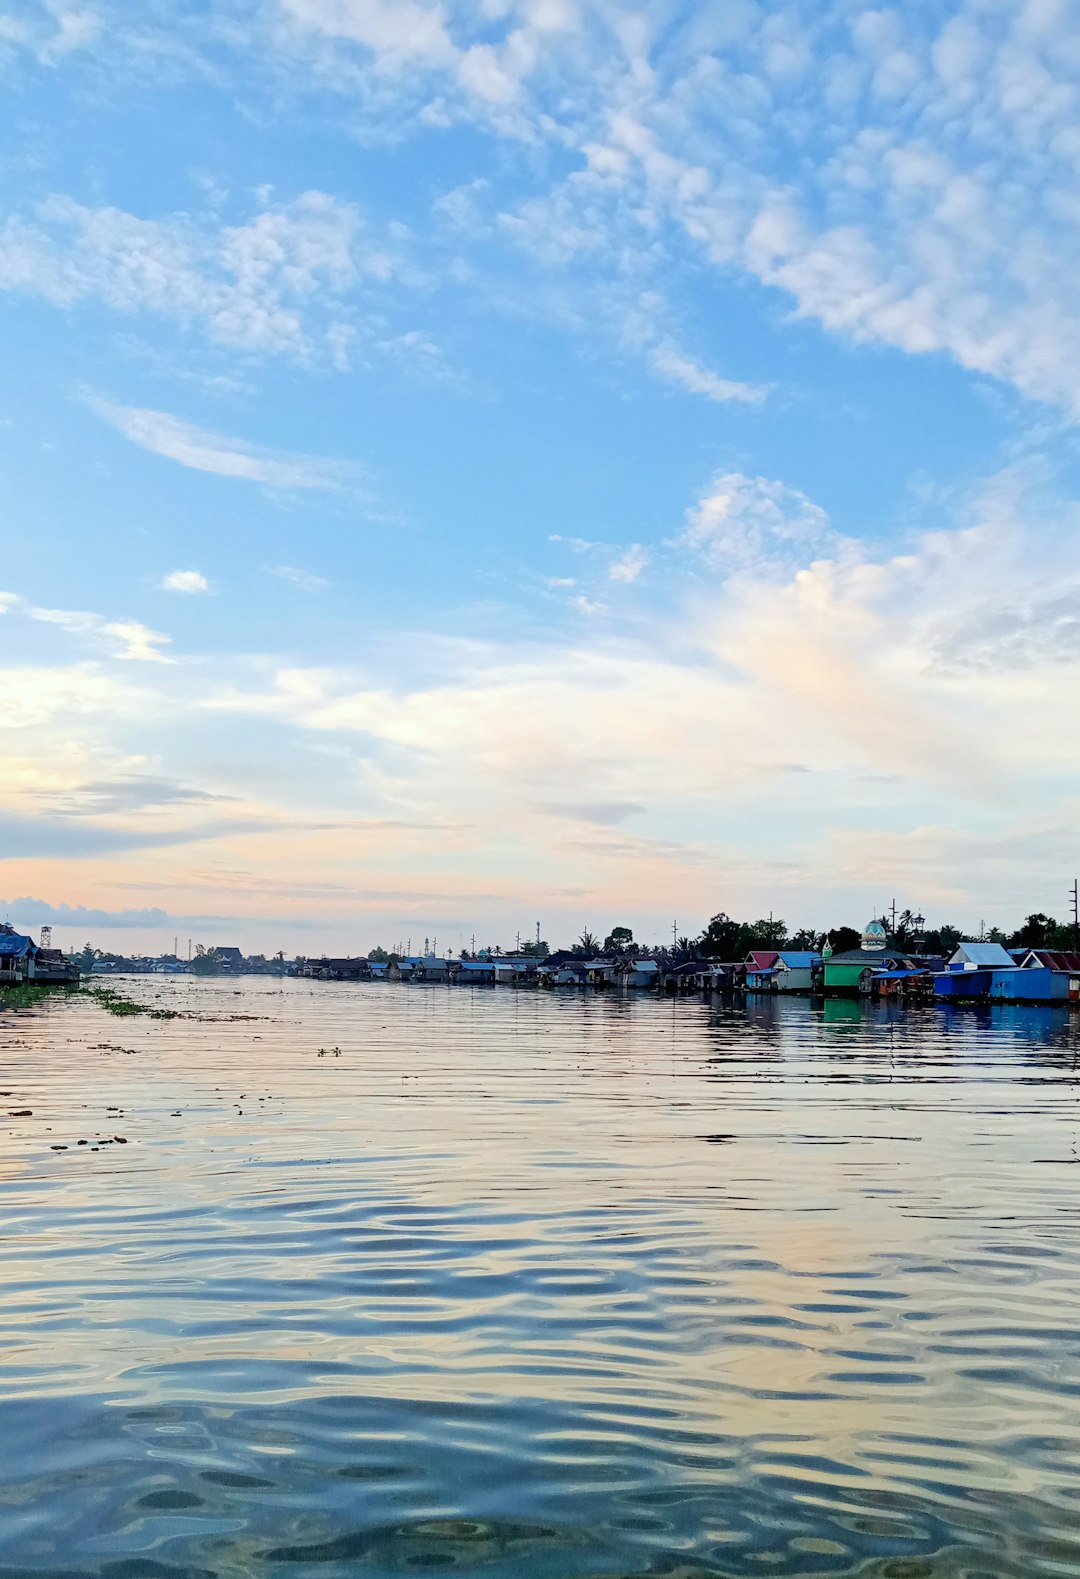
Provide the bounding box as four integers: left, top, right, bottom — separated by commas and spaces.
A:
0, 977, 1080, 1579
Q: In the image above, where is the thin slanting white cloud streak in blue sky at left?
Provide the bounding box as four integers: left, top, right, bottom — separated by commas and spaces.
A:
85, 395, 353, 486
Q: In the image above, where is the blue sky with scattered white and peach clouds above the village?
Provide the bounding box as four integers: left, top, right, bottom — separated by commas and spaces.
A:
0, 0, 1080, 954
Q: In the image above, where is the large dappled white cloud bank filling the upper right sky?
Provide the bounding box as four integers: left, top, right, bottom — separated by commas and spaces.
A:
265, 0, 1080, 418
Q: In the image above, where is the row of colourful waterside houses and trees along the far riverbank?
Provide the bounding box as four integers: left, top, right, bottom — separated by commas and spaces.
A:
0, 913, 1080, 1011
